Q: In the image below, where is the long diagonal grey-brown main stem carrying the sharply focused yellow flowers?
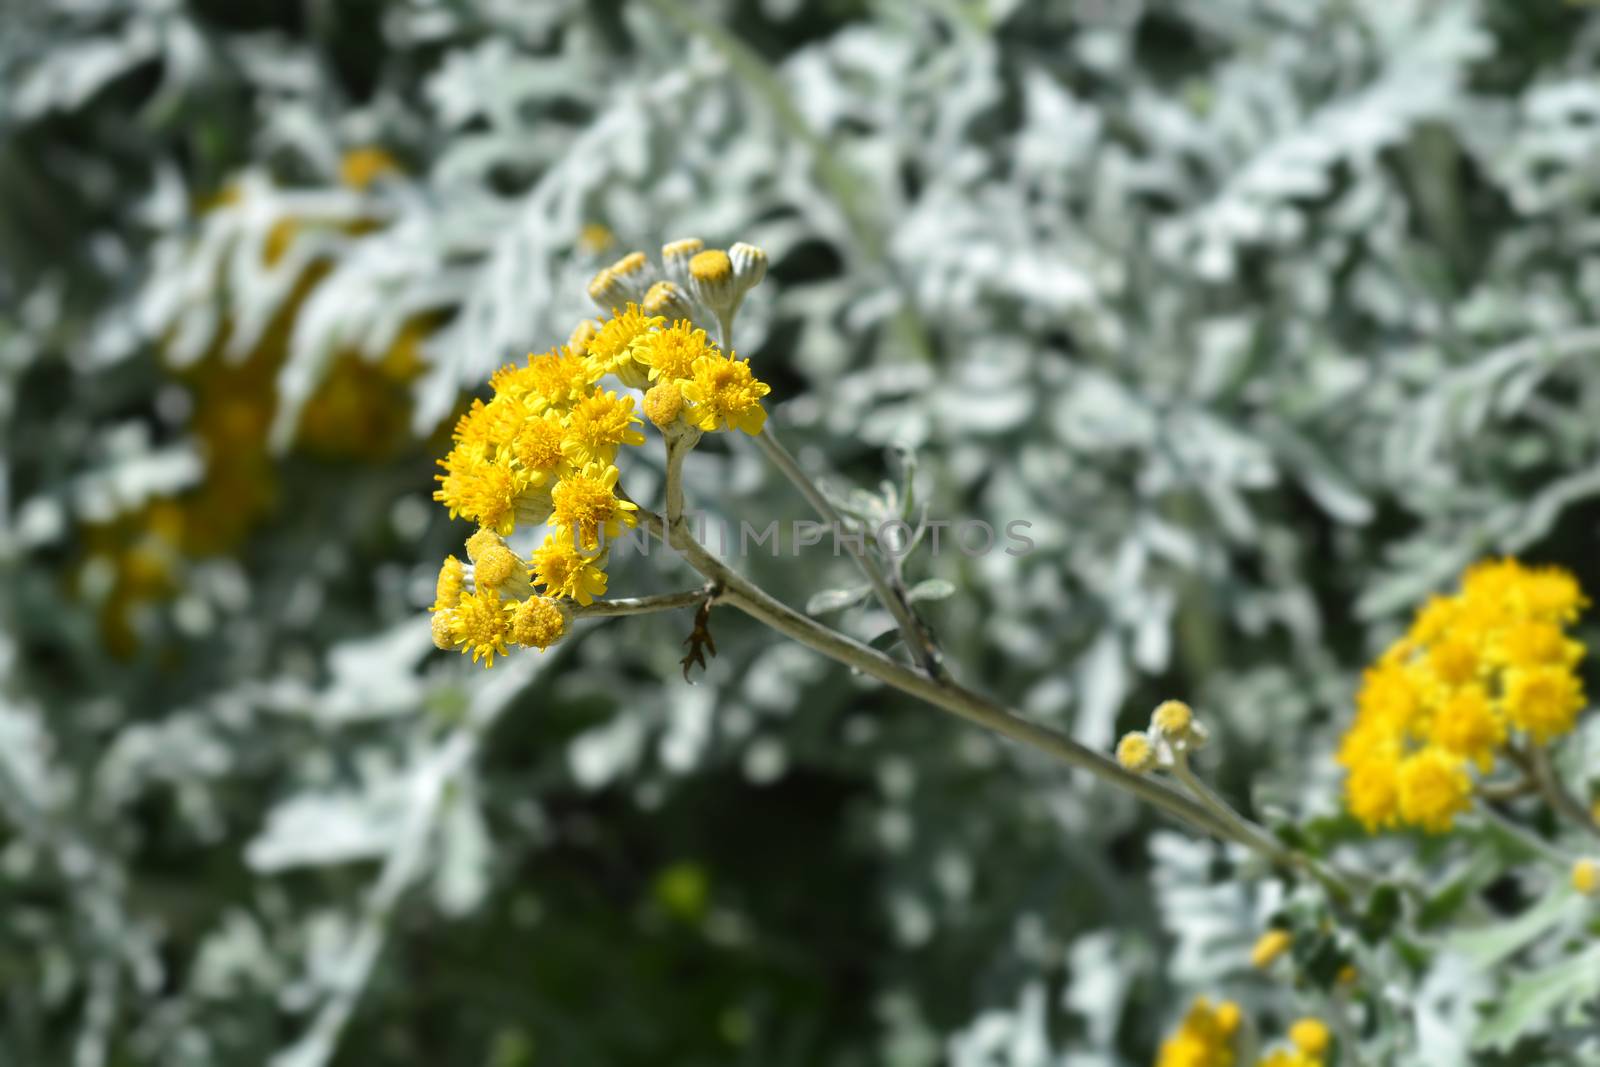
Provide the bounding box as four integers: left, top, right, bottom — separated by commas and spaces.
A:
638, 442, 1254, 861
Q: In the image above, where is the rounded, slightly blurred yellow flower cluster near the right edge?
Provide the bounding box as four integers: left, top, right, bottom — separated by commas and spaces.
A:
1338, 560, 1587, 832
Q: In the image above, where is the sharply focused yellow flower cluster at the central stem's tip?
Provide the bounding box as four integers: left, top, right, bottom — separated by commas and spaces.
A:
432, 245, 770, 665
